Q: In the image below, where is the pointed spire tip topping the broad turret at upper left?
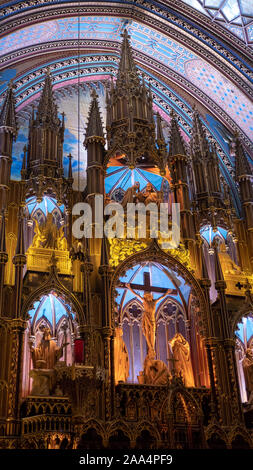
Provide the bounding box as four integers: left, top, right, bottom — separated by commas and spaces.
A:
36, 69, 59, 127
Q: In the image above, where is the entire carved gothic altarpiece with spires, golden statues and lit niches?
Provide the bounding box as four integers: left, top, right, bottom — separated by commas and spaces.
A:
0, 32, 253, 449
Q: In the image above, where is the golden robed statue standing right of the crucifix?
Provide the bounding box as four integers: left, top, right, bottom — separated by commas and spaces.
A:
169, 333, 195, 387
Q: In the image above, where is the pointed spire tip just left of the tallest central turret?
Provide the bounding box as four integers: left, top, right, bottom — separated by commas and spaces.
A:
84, 89, 104, 145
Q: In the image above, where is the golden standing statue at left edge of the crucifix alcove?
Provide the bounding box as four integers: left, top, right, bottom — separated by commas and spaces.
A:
114, 327, 129, 384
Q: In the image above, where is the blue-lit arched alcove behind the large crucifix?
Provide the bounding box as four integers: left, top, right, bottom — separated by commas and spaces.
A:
114, 260, 209, 387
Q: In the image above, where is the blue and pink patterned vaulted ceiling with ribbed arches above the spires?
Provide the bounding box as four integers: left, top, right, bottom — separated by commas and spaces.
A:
0, 0, 253, 200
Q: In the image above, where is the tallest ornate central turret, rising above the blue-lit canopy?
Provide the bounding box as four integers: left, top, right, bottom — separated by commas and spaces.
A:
106, 30, 165, 174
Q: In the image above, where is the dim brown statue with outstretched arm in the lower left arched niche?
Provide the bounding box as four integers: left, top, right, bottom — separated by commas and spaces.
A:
30, 328, 69, 396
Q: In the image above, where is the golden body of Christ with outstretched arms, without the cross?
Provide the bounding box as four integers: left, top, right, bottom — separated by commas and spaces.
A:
126, 284, 171, 358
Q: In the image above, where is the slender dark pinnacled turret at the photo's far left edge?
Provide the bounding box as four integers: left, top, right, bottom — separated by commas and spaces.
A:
0, 82, 17, 209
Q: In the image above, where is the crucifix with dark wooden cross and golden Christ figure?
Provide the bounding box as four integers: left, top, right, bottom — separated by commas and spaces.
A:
123, 272, 177, 359
